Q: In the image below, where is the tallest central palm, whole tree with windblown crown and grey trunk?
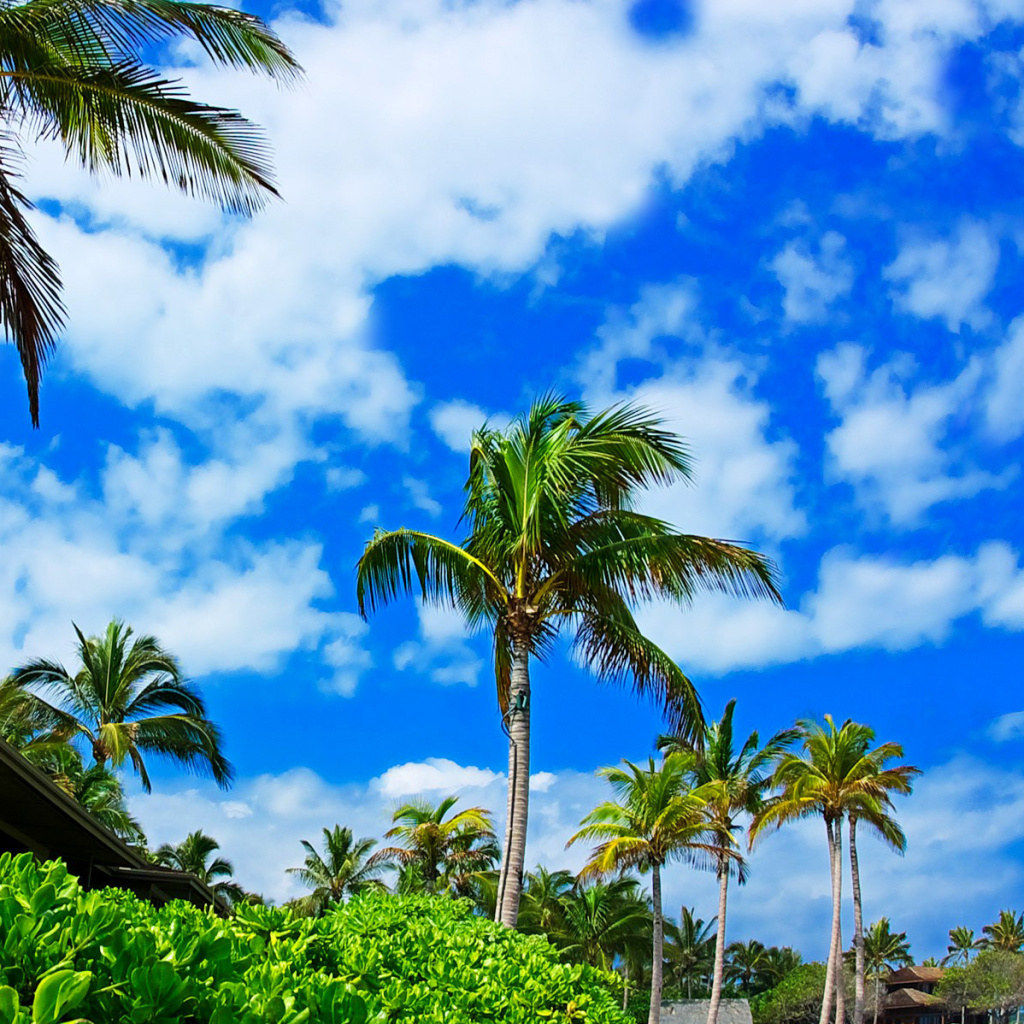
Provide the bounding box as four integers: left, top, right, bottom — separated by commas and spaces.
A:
356, 395, 781, 927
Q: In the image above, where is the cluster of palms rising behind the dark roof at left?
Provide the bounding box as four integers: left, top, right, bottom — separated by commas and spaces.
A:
0, 620, 233, 846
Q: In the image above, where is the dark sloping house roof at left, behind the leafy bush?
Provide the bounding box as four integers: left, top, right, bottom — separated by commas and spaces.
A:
0, 740, 225, 910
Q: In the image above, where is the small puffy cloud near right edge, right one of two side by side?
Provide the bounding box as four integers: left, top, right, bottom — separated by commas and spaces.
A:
885, 220, 999, 332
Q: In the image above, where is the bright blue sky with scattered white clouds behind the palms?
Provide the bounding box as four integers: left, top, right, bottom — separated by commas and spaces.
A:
0, 0, 1024, 957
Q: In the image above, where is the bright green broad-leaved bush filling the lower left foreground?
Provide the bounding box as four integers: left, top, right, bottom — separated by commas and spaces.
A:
0, 854, 627, 1024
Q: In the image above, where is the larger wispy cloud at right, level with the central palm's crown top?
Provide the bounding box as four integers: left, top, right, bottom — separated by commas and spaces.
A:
817, 344, 1014, 524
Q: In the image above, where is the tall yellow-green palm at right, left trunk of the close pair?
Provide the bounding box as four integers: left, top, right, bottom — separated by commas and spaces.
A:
751, 715, 916, 1024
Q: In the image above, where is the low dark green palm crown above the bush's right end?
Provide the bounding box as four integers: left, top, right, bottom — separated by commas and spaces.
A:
553, 878, 652, 971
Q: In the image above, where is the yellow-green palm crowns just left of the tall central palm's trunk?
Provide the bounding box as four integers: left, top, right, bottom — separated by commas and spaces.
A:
370, 797, 498, 894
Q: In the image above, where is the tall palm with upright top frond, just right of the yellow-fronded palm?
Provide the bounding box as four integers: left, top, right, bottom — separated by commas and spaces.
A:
658, 700, 797, 1024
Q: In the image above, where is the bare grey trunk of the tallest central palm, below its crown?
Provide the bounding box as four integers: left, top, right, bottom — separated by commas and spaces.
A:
495, 639, 529, 928
